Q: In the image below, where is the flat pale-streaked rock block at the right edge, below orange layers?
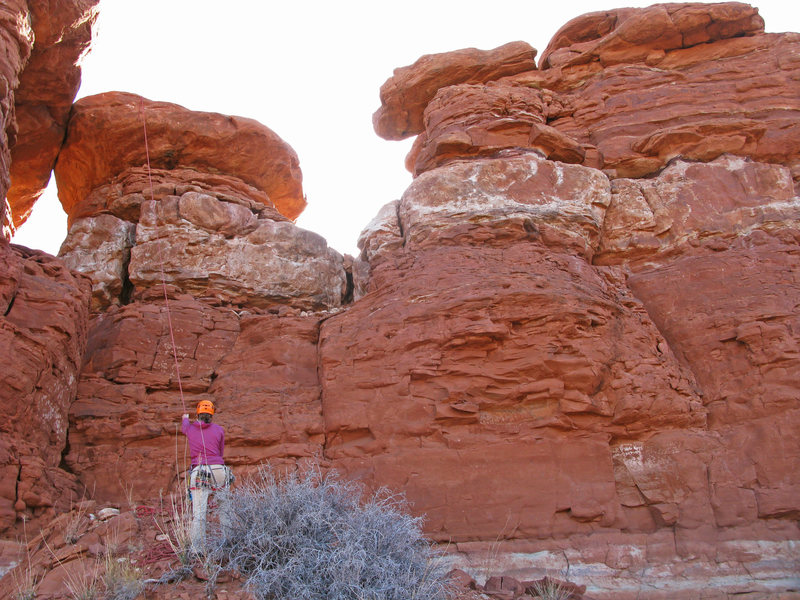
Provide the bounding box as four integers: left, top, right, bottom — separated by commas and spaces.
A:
596, 155, 800, 264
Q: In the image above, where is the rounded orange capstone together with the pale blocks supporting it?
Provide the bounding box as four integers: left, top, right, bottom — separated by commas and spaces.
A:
56, 93, 347, 309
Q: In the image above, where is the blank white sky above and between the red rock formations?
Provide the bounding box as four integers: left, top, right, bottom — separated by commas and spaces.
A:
12, 0, 800, 255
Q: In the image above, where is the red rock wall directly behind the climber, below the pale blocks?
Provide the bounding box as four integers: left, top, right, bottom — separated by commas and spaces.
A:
66, 295, 322, 500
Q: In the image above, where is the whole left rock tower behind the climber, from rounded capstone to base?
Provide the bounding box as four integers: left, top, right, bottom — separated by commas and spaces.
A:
50, 94, 344, 499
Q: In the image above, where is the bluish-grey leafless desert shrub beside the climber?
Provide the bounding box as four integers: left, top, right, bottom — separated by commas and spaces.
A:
211, 468, 449, 600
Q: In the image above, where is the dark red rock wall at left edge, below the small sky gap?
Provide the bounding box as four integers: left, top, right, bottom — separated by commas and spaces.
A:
0, 243, 89, 532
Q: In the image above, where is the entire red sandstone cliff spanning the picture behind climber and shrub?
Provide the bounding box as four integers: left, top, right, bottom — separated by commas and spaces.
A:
0, 3, 800, 598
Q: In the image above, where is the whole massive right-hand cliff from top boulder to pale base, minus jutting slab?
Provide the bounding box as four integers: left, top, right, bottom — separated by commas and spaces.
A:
366, 3, 800, 598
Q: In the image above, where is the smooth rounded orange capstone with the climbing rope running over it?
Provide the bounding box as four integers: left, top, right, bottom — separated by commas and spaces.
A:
55, 92, 306, 224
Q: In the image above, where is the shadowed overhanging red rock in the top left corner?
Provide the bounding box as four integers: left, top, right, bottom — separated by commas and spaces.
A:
0, 0, 98, 238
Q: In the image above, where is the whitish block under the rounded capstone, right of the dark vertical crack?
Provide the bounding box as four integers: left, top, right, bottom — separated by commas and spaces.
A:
128, 192, 347, 309
